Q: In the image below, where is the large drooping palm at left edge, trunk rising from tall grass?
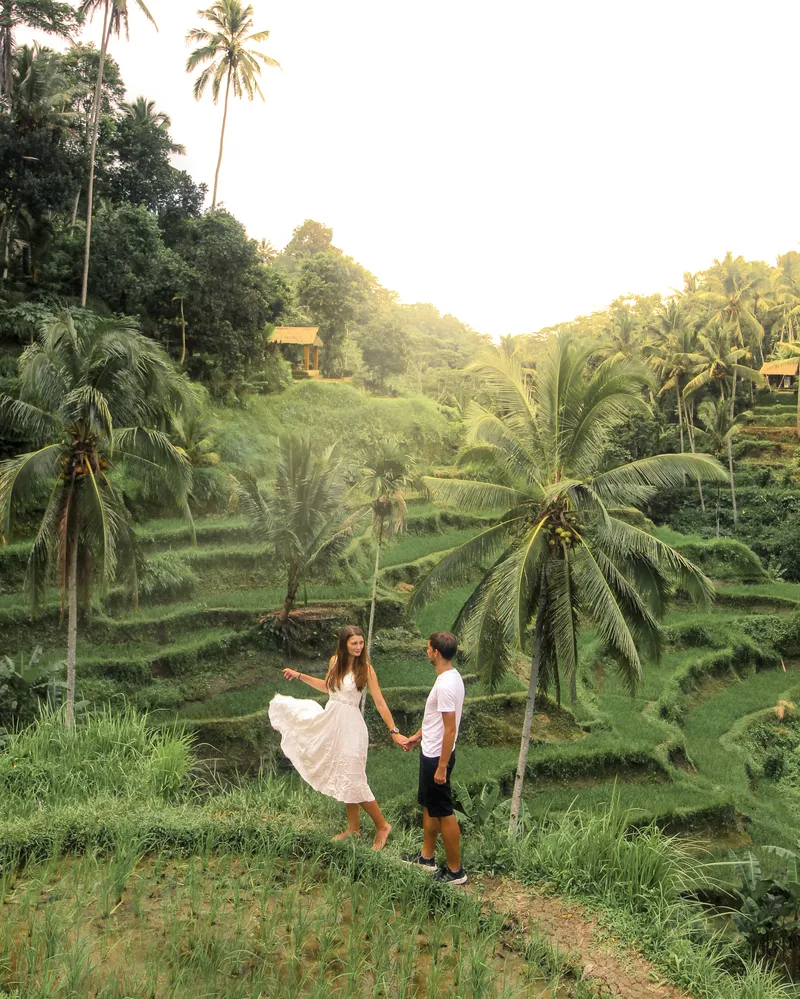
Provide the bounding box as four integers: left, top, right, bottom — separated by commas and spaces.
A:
0, 311, 190, 725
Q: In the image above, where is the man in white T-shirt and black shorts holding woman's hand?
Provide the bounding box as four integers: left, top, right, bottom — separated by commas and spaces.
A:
403, 631, 467, 885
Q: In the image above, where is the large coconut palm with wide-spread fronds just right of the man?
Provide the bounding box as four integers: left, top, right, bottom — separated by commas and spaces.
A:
412, 336, 726, 834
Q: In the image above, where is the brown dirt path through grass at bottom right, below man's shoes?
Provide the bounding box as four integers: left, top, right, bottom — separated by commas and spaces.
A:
473, 878, 691, 999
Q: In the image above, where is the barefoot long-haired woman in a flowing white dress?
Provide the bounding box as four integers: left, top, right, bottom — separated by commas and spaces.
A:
269, 625, 402, 850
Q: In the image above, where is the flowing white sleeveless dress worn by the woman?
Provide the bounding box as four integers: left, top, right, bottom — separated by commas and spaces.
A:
269, 673, 375, 804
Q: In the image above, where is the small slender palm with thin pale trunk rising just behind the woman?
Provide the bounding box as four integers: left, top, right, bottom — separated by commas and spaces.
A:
359, 437, 414, 653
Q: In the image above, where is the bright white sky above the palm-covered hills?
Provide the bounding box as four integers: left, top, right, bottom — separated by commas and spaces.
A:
26, 0, 800, 336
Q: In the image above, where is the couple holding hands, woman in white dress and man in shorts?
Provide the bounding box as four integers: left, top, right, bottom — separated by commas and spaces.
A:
269, 625, 467, 885
